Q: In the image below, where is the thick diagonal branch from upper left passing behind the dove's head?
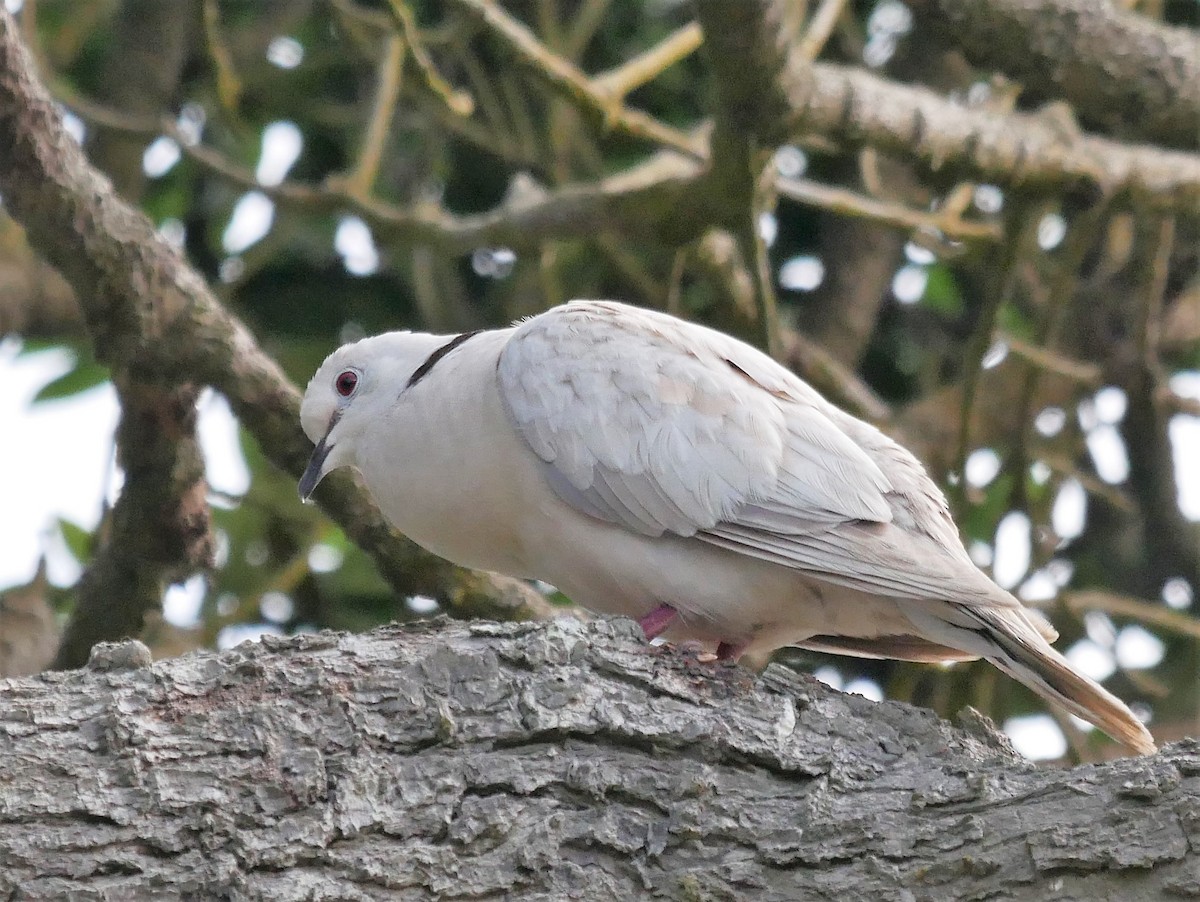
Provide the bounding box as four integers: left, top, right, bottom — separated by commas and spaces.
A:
0, 11, 541, 647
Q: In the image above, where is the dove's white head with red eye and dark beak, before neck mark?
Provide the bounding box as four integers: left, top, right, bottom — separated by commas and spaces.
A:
300, 332, 445, 501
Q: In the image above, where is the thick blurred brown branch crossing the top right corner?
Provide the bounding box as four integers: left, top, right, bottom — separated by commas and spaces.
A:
908, 0, 1200, 150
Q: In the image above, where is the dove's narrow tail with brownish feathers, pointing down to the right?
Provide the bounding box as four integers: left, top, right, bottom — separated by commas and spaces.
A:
914, 606, 1157, 754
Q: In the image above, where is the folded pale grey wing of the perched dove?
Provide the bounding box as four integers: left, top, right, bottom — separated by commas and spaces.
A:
497, 301, 993, 605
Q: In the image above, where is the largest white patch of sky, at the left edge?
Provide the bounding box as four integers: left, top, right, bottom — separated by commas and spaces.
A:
0, 339, 119, 588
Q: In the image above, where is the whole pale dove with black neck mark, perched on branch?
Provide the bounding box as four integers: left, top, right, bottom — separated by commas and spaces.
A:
300, 301, 1154, 753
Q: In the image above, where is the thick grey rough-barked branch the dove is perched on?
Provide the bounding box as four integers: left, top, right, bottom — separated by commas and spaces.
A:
0, 620, 1200, 902
